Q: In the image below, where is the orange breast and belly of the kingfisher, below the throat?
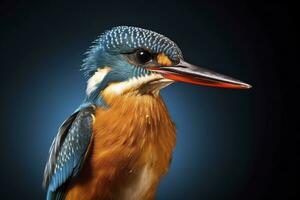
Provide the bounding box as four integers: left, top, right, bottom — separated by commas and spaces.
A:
66, 95, 176, 200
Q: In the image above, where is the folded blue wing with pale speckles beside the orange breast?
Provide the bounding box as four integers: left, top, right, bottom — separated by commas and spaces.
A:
43, 106, 94, 200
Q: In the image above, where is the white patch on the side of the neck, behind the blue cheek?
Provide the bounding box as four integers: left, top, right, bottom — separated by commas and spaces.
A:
86, 67, 111, 96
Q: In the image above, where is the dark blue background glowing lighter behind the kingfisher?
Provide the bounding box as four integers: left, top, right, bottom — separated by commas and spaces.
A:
0, 0, 289, 199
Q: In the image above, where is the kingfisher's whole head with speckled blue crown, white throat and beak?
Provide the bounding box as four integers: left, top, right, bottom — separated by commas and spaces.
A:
82, 26, 251, 101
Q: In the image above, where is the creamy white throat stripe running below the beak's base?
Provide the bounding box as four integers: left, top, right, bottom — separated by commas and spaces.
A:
105, 74, 163, 95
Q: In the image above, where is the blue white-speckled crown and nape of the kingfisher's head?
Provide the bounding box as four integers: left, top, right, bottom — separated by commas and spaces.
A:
81, 26, 183, 77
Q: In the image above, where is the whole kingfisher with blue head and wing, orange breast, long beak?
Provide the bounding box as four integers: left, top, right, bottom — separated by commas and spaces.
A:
43, 26, 251, 200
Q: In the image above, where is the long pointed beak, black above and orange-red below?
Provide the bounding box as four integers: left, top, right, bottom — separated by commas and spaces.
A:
150, 60, 251, 89
